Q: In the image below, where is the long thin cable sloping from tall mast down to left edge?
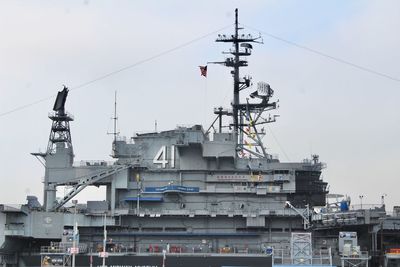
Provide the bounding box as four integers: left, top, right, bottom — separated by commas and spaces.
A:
0, 24, 232, 117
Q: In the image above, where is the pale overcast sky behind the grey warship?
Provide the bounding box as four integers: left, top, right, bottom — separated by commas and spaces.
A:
0, 0, 400, 213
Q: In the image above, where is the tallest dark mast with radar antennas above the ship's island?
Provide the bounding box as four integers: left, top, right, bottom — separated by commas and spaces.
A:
214, 9, 277, 158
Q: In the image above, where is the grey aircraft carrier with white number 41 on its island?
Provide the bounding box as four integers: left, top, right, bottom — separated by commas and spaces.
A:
0, 10, 400, 267
